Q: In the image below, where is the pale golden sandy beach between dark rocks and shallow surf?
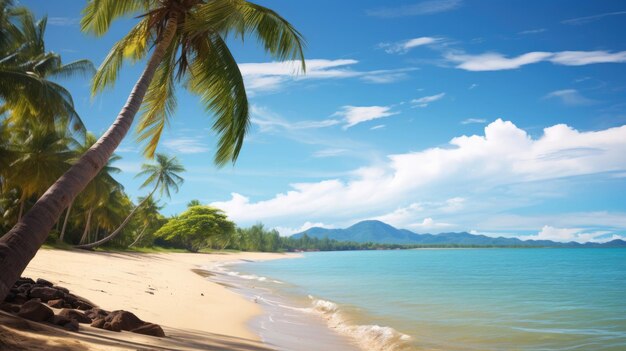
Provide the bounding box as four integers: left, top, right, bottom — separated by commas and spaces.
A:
0, 250, 294, 350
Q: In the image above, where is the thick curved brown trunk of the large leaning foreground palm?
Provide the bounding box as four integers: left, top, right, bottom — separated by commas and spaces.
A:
0, 14, 177, 301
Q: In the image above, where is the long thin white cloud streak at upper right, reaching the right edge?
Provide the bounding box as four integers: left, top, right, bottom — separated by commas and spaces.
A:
445, 51, 626, 71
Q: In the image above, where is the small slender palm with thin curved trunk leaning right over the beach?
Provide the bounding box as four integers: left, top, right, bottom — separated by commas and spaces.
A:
76, 154, 185, 249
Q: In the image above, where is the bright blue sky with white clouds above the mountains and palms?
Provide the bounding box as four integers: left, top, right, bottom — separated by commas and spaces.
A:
20, 0, 626, 241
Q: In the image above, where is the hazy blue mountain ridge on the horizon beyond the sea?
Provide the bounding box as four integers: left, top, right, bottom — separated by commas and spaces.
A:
292, 220, 626, 247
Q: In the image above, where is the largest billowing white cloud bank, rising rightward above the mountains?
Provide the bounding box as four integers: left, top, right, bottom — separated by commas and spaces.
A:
213, 120, 626, 236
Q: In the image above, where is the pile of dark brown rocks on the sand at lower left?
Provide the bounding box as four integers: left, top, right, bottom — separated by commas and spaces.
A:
0, 278, 165, 337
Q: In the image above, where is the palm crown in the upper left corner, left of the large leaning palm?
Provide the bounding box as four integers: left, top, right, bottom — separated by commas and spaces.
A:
0, 7, 95, 131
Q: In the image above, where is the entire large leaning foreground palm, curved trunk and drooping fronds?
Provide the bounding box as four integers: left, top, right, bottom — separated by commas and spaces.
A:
0, 0, 304, 299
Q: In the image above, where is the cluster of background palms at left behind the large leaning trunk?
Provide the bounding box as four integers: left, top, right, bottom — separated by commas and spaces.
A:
0, 1, 184, 252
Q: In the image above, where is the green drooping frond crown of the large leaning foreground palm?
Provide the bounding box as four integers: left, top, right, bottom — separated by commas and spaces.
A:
81, 0, 305, 165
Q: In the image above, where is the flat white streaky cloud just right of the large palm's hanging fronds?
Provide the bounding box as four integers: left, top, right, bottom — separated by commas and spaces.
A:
239, 59, 414, 93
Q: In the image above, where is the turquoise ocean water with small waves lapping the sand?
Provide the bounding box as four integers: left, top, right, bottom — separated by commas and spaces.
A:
229, 249, 626, 351
